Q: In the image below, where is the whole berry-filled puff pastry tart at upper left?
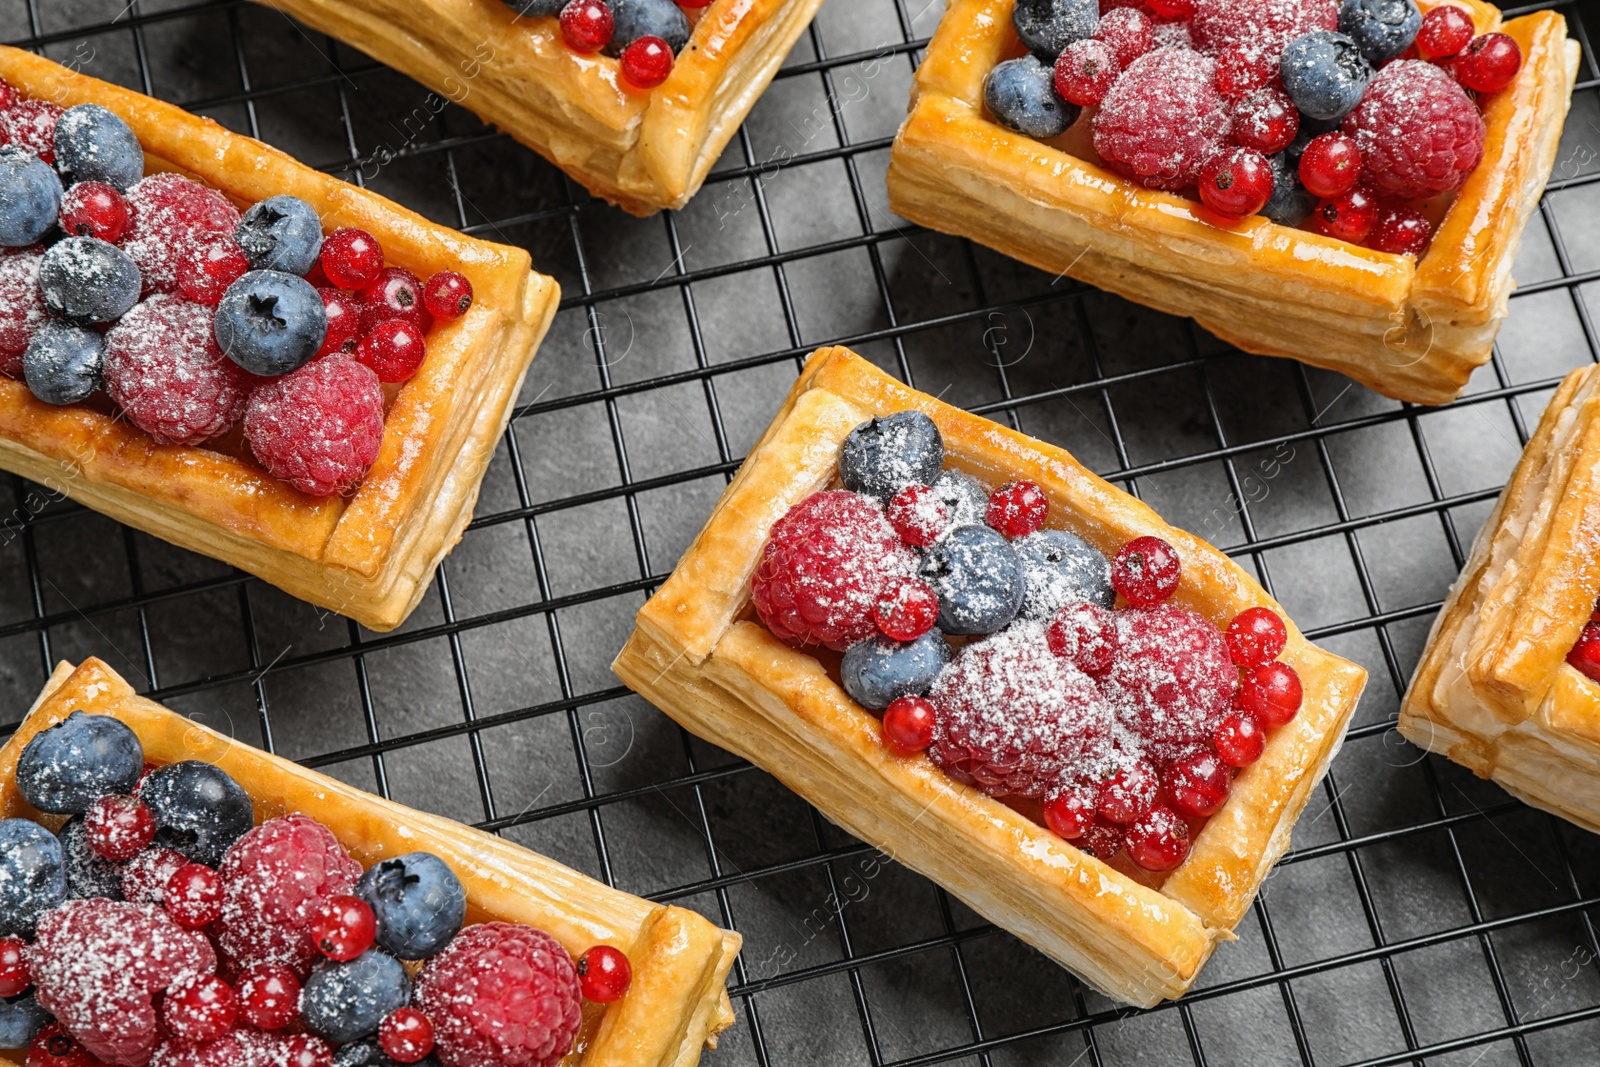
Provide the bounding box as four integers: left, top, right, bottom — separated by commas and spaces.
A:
0, 48, 560, 630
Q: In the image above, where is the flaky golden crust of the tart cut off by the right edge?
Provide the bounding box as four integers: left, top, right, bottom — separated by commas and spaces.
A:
1400, 366, 1600, 832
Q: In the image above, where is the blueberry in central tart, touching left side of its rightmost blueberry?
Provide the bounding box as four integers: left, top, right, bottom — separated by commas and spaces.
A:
917, 526, 1022, 633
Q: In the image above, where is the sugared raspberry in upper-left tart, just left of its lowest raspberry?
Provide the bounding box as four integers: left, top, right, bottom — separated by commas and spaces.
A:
106, 294, 251, 445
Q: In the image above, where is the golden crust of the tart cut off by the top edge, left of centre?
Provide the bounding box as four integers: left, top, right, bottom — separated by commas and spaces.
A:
249, 0, 822, 216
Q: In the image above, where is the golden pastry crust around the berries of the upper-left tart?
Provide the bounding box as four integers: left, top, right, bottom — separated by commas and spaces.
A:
0, 46, 560, 630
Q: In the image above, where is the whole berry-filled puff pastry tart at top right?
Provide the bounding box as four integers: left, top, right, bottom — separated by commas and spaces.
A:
888, 0, 1579, 403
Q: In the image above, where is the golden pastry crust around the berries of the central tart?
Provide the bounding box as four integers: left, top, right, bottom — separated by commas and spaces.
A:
613, 349, 1366, 1006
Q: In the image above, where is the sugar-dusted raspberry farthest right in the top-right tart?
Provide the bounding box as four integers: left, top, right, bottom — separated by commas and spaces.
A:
1344, 59, 1485, 200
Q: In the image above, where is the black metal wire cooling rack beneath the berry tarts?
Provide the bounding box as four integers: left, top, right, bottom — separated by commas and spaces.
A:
9, 0, 1600, 1067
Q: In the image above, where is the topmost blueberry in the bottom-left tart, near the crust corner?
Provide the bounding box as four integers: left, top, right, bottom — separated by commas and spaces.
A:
16, 712, 144, 814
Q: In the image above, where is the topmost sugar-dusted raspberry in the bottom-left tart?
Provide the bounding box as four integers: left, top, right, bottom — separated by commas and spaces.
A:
216, 814, 362, 977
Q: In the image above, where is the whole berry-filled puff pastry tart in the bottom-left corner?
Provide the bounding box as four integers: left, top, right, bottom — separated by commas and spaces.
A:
0, 659, 739, 1067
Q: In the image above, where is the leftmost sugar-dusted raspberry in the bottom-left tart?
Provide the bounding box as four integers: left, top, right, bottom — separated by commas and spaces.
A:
29, 899, 216, 1067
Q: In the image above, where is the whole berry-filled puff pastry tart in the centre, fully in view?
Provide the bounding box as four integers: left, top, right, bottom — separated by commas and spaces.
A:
613, 349, 1366, 1005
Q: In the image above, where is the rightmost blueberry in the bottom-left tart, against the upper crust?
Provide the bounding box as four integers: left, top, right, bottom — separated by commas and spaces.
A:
355, 853, 467, 960
